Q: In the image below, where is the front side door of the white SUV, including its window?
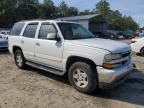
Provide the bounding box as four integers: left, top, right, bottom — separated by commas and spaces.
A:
35, 23, 63, 69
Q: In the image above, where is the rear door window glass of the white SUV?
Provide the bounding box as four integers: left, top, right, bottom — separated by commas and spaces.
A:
23, 23, 38, 38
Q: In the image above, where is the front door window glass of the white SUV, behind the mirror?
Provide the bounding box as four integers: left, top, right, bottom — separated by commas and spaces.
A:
38, 23, 57, 39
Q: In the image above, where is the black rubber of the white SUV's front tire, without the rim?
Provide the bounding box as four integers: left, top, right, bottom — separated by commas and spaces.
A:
68, 62, 98, 93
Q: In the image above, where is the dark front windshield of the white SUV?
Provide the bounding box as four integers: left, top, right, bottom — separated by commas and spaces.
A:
58, 23, 94, 40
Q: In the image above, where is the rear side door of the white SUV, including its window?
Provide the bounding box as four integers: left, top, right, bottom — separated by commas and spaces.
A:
21, 23, 38, 61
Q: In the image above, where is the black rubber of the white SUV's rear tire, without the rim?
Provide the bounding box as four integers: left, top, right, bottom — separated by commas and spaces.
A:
14, 50, 25, 69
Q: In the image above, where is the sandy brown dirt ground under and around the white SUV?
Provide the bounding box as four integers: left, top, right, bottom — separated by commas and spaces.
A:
0, 53, 144, 108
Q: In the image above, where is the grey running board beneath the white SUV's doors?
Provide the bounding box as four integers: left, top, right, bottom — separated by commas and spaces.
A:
26, 62, 65, 76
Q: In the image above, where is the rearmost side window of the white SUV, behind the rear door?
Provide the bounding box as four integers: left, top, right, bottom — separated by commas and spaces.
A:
10, 23, 25, 36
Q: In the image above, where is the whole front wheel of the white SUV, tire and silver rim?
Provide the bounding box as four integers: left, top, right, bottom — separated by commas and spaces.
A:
68, 62, 98, 93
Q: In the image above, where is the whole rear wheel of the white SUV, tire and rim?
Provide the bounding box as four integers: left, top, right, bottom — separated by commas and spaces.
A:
14, 49, 26, 69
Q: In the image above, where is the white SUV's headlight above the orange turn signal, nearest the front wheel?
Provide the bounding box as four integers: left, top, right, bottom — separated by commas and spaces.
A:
104, 54, 121, 63
